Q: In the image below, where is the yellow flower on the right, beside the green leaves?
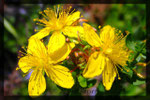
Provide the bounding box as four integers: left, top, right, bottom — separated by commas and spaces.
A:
83, 23, 129, 90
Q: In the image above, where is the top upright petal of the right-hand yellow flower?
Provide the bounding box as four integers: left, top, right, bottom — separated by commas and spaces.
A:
100, 25, 115, 44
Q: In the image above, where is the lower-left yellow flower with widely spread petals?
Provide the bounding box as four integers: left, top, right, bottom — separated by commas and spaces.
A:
18, 38, 75, 96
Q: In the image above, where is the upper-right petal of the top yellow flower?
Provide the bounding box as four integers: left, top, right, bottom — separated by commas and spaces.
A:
66, 11, 80, 25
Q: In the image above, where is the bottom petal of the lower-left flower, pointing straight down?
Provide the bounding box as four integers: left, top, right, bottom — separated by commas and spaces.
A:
28, 69, 46, 96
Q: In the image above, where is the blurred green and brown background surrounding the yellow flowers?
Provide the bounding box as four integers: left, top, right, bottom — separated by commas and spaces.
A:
4, 4, 146, 96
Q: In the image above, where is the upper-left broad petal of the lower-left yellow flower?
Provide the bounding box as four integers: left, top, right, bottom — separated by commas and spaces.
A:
27, 38, 47, 58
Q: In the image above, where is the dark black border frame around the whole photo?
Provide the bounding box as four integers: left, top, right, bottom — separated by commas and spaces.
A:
0, 0, 150, 100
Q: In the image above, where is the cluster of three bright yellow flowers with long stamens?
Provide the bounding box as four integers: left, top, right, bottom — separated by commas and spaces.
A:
18, 6, 129, 96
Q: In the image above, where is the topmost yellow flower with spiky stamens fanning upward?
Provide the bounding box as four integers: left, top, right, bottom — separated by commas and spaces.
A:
31, 5, 83, 53
